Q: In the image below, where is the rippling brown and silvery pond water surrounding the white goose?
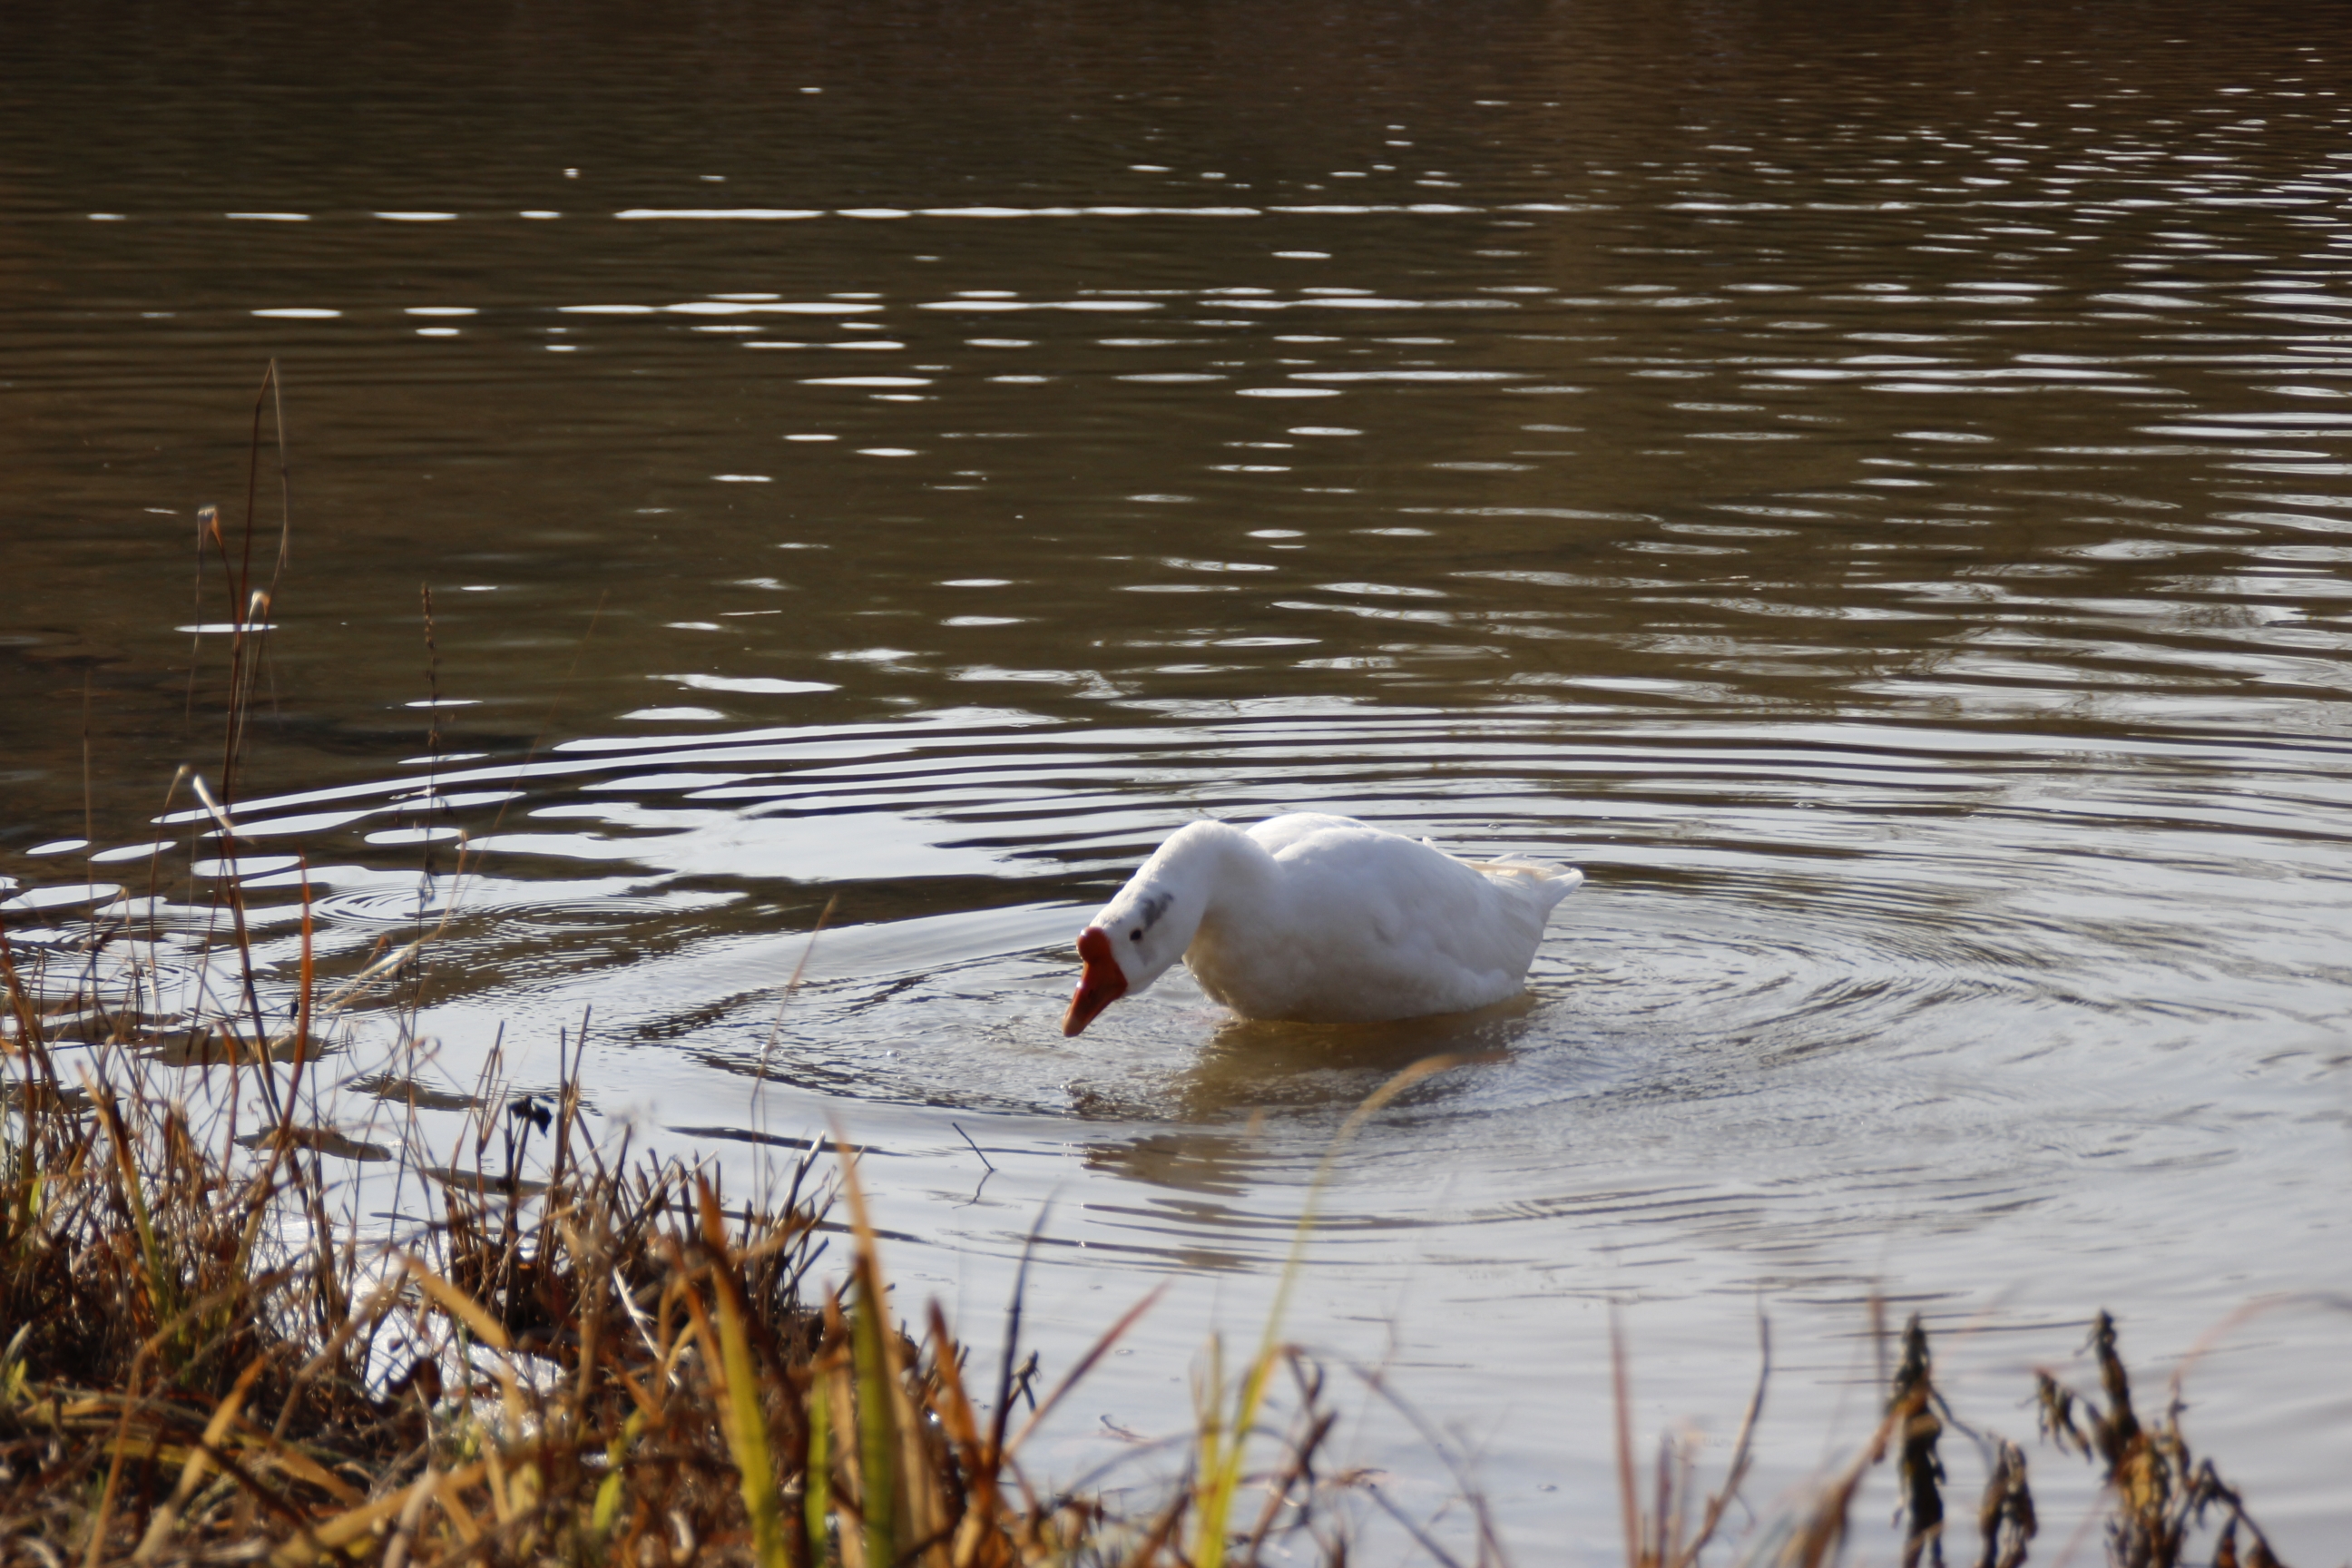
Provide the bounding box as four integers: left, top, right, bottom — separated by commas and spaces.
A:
0, 5, 2352, 1561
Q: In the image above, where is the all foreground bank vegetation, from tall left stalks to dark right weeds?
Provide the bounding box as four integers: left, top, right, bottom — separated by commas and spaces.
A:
0, 380, 2277, 1568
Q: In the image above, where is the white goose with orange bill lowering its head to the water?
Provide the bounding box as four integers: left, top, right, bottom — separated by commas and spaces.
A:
1061, 811, 1585, 1034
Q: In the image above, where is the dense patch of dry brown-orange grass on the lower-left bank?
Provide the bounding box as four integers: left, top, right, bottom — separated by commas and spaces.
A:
0, 968, 1392, 1568
